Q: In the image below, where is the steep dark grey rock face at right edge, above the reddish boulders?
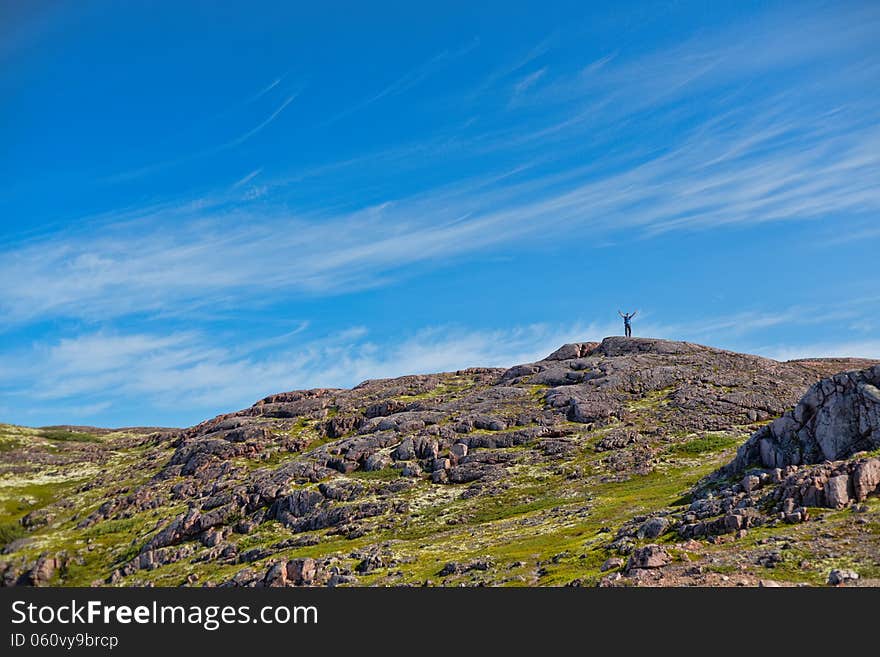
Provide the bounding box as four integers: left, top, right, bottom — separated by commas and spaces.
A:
725, 365, 880, 474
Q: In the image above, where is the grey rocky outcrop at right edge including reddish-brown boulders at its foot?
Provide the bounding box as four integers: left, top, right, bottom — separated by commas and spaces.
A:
648, 365, 880, 538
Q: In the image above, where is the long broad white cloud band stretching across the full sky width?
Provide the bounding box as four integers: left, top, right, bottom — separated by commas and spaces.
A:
0, 89, 880, 323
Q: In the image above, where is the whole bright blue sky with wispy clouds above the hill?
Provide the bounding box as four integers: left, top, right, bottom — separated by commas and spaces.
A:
0, 1, 880, 426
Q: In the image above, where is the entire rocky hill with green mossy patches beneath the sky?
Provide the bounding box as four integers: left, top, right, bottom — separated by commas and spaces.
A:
0, 337, 880, 586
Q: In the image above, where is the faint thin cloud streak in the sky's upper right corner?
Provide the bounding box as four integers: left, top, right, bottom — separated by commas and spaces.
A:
516, 4, 880, 111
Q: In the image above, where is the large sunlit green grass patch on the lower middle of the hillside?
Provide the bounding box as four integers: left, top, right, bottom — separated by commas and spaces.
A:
348, 456, 713, 586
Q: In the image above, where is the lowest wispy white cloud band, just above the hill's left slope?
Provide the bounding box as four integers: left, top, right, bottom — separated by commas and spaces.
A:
0, 324, 599, 424
